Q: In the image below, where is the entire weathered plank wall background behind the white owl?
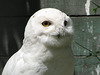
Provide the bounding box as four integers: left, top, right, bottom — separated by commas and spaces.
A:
0, 0, 100, 75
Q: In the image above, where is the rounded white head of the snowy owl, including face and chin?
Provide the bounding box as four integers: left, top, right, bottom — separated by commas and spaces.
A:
25, 8, 73, 46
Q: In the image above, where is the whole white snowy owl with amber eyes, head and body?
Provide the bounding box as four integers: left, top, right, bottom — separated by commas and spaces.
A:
2, 8, 74, 75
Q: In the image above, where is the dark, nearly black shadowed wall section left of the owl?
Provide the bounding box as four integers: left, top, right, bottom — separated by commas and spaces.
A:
0, 0, 40, 75
